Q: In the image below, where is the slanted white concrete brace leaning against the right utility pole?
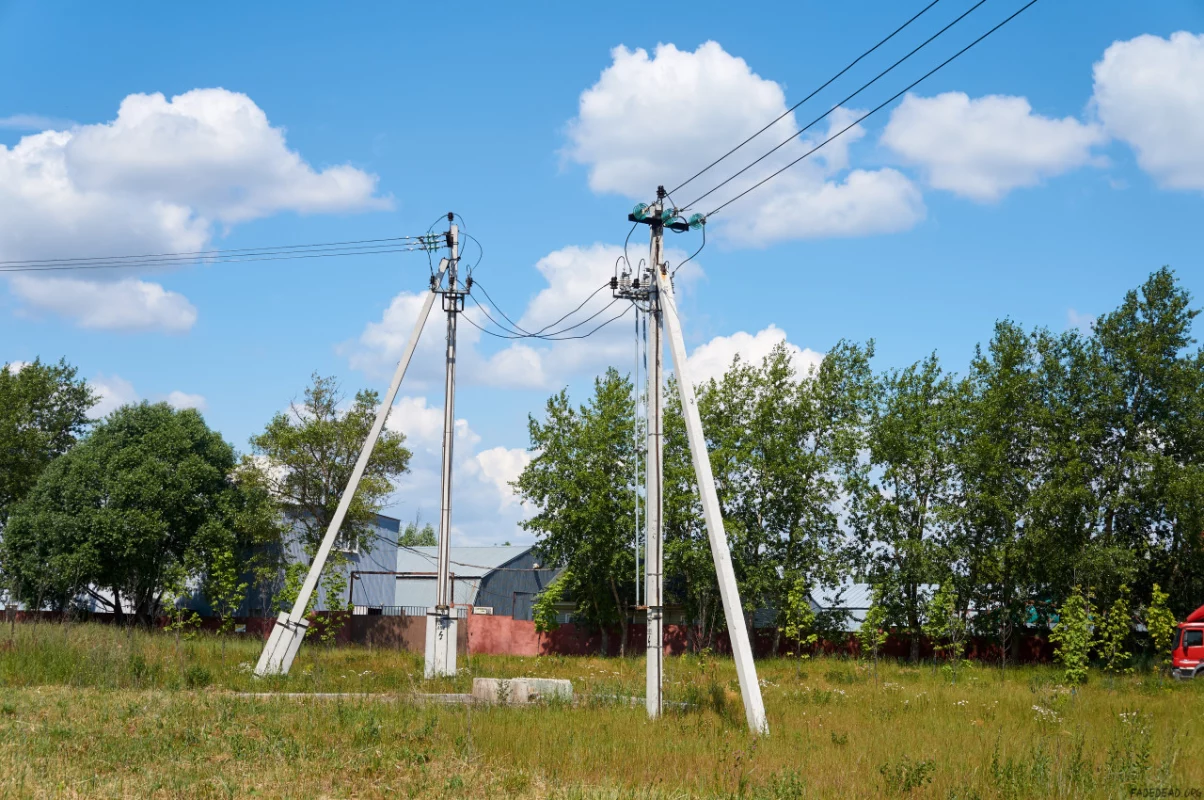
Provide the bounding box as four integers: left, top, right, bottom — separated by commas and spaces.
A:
653, 264, 769, 734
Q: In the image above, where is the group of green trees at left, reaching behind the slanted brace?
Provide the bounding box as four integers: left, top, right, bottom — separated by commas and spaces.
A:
0, 368, 414, 624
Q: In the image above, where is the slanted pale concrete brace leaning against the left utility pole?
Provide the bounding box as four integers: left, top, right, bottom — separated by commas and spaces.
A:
255, 259, 449, 676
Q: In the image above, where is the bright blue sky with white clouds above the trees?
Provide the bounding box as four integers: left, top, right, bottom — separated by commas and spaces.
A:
0, 0, 1204, 543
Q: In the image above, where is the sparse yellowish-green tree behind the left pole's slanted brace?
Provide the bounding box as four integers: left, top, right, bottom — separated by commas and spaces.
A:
244, 373, 411, 555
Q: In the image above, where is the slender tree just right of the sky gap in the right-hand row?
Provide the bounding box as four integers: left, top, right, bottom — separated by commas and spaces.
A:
852, 355, 961, 661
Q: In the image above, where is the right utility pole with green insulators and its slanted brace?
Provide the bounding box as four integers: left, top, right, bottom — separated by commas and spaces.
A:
610, 187, 769, 734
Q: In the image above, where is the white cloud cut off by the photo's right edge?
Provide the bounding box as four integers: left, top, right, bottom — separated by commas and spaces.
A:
1092, 31, 1204, 190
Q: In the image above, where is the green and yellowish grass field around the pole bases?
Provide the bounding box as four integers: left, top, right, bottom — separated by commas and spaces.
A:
0, 624, 1204, 800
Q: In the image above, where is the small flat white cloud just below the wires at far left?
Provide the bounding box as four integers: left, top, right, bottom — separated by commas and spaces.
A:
10, 275, 196, 334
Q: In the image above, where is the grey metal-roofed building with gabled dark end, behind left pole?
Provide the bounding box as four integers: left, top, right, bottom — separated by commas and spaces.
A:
394, 545, 560, 619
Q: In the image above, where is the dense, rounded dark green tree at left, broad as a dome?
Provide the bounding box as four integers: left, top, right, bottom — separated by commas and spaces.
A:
0, 402, 279, 623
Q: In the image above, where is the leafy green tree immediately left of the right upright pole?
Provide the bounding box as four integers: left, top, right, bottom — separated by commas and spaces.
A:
515, 369, 638, 654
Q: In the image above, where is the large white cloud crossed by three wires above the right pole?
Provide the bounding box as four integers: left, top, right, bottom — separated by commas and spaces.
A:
563, 41, 925, 245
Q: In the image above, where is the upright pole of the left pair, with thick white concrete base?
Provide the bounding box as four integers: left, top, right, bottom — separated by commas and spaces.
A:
424, 213, 465, 678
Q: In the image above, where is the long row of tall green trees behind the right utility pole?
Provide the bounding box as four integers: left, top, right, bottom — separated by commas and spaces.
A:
515, 269, 1204, 658
